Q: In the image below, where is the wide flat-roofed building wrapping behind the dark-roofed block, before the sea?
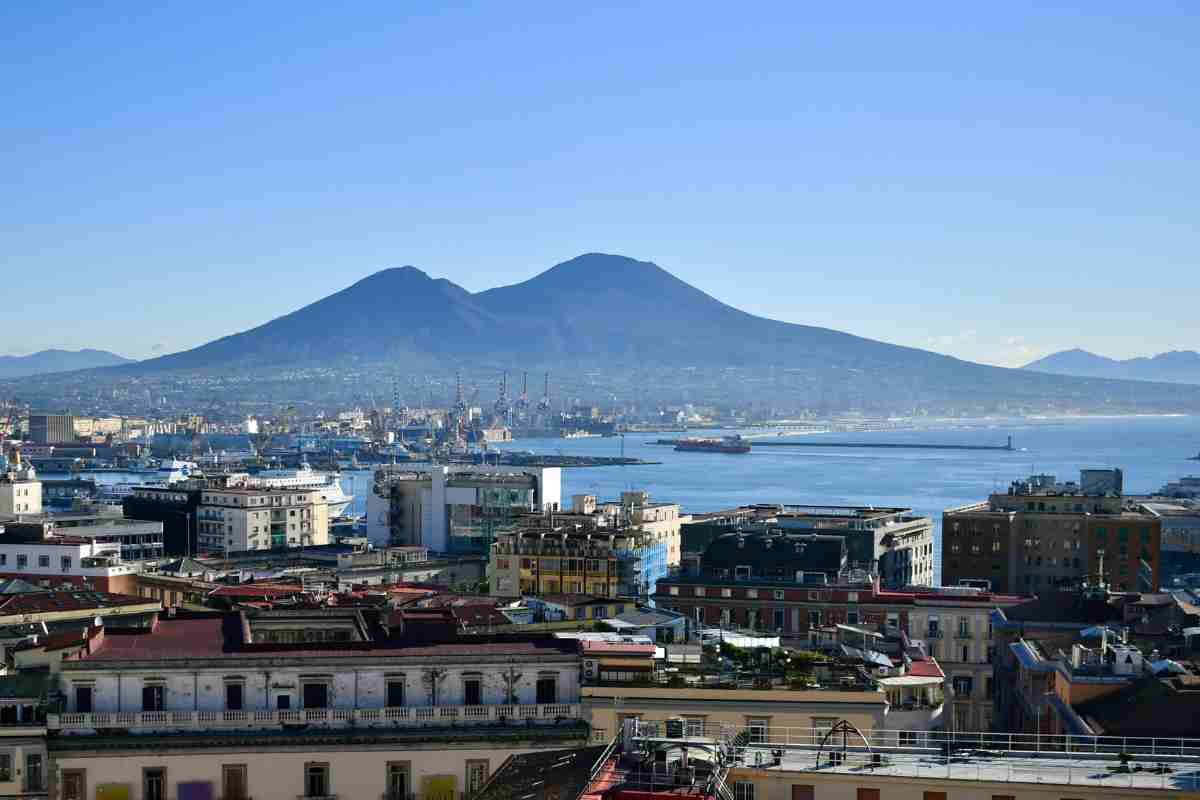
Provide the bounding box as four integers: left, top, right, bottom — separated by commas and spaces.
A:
683, 504, 934, 589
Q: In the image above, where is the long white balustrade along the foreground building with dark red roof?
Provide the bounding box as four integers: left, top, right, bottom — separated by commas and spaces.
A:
47, 703, 580, 733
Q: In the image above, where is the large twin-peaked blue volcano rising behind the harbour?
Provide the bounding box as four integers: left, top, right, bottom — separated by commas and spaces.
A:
96, 253, 1200, 413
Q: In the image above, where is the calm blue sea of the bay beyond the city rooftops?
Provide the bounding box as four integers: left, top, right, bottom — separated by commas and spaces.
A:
54, 416, 1200, 575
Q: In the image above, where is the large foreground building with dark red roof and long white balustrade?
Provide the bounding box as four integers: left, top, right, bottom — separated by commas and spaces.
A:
47, 609, 588, 800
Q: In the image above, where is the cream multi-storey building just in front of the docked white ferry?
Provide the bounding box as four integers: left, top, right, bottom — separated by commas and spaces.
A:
196, 485, 329, 553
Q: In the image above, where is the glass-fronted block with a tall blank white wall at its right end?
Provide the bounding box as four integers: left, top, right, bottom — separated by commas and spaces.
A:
367, 465, 562, 554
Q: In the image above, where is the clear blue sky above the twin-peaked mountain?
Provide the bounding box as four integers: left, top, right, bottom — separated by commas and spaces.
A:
0, 1, 1200, 365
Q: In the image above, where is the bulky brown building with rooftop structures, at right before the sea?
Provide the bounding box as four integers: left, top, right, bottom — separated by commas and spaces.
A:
942, 470, 1162, 594
